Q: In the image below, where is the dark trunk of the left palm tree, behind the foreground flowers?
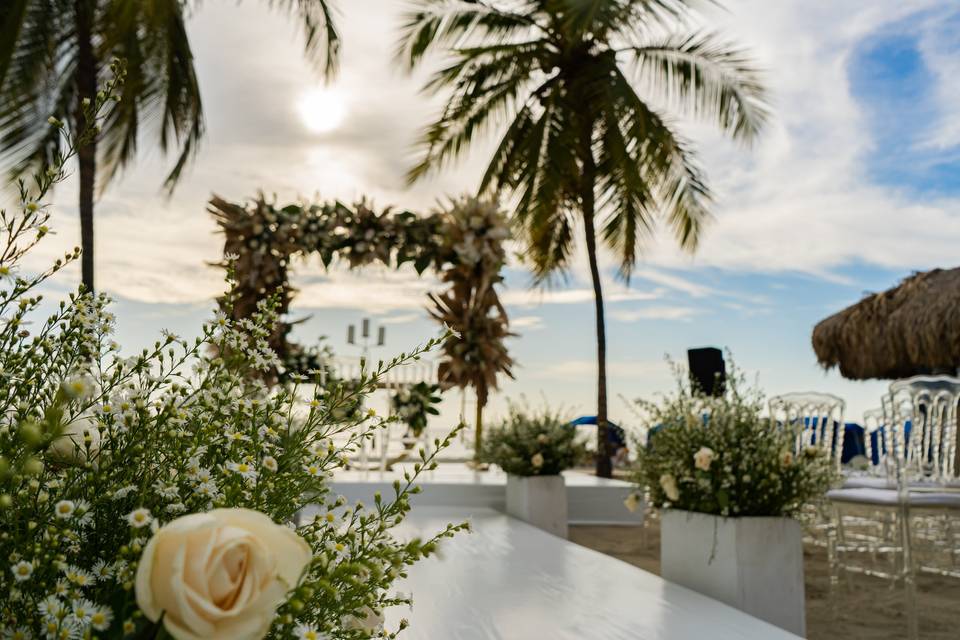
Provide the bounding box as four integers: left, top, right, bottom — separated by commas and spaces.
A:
74, 0, 97, 293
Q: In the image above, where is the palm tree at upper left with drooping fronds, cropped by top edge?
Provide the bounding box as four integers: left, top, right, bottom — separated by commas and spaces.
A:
0, 0, 339, 291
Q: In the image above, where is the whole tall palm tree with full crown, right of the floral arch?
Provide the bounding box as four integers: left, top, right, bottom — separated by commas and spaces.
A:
400, 0, 767, 477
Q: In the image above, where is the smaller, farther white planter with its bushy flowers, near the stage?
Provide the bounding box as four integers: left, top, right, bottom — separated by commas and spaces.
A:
481, 406, 585, 537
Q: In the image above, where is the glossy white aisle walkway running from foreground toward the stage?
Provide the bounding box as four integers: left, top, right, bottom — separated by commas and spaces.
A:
386, 507, 797, 640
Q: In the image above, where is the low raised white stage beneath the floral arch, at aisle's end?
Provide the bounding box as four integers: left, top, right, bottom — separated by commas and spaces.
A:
330, 463, 643, 526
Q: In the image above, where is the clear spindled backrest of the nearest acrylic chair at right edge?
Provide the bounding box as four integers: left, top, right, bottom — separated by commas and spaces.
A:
883, 376, 960, 482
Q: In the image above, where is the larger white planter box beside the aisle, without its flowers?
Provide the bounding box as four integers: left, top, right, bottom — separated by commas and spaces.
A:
660, 509, 806, 637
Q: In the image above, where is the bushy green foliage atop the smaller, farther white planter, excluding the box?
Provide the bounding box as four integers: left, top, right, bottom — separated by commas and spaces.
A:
481, 406, 585, 476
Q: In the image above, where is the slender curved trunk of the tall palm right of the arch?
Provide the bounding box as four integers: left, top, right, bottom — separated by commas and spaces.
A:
580, 124, 613, 478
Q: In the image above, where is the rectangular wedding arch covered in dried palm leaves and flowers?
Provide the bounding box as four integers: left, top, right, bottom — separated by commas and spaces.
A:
208, 194, 513, 451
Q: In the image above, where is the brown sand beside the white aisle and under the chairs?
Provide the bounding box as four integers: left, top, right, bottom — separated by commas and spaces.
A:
570, 520, 960, 640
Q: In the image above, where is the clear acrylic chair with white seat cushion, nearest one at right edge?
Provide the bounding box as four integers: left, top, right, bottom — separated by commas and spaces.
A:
827, 376, 960, 639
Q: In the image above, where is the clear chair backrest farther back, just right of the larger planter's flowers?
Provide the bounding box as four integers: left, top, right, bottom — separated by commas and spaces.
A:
769, 392, 846, 469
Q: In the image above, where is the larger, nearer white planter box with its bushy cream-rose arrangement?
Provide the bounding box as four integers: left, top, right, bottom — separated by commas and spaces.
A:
636, 362, 832, 635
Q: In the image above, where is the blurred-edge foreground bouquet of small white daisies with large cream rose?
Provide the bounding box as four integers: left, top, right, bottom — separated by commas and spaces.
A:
0, 72, 461, 640
